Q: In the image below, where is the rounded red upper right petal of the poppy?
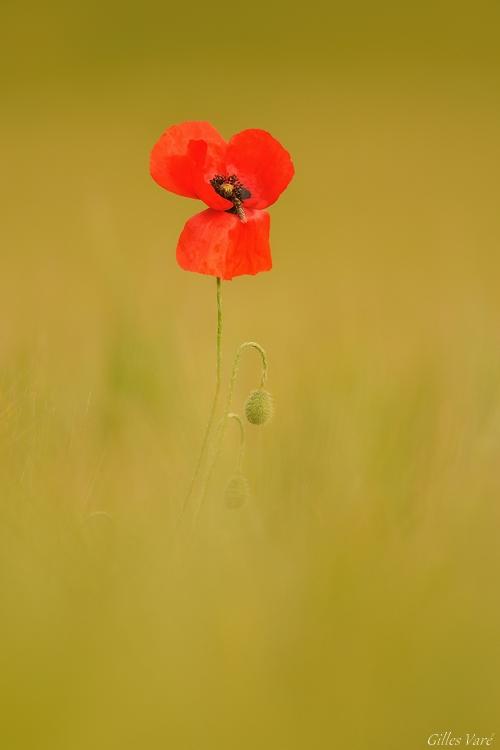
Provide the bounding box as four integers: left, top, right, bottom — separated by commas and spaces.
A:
226, 129, 294, 208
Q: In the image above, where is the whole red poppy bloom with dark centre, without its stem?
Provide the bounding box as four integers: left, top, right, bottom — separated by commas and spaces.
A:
150, 122, 294, 279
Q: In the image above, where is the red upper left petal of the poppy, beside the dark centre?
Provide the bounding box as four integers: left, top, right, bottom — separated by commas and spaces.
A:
150, 122, 227, 210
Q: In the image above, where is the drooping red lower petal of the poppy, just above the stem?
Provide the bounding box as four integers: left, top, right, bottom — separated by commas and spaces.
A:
177, 209, 272, 279
